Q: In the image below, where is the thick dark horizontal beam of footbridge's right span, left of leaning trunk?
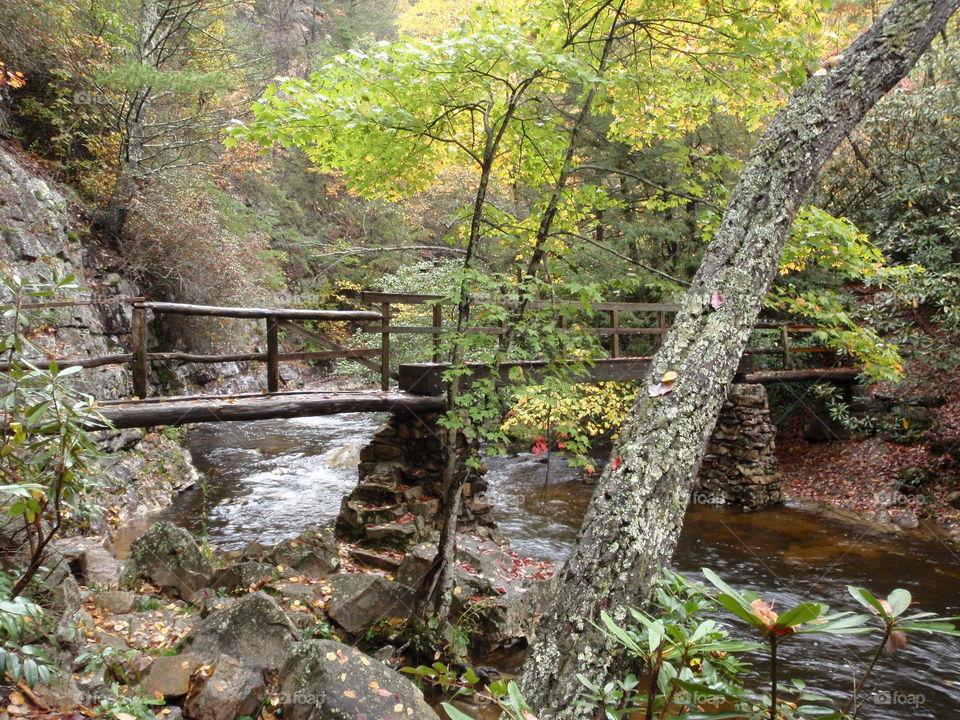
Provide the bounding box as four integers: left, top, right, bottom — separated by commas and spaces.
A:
399, 357, 650, 396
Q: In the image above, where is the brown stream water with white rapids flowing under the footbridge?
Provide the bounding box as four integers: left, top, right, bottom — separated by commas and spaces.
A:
165, 414, 960, 720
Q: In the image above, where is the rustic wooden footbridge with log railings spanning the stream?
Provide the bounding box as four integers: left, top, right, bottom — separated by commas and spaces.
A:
0, 292, 858, 428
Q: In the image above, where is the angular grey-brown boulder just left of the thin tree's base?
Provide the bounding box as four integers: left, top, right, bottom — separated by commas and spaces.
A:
327, 574, 415, 635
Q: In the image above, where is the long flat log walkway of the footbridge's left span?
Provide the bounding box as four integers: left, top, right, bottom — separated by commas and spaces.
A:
90, 392, 446, 429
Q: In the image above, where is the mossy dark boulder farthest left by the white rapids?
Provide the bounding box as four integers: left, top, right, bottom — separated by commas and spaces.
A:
130, 522, 213, 599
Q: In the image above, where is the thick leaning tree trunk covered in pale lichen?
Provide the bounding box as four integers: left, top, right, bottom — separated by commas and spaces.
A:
520, 0, 960, 720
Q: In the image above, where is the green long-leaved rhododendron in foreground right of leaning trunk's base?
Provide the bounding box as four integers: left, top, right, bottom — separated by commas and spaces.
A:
568, 569, 958, 720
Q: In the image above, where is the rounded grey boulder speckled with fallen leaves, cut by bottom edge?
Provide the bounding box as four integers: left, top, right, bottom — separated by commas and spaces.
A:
281, 640, 438, 720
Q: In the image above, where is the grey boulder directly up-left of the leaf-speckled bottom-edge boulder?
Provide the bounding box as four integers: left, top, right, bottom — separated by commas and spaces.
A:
183, 592, 299, 670
